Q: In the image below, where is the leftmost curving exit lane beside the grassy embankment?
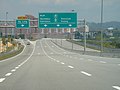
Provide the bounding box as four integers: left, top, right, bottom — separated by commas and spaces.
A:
0, 45, 33, 78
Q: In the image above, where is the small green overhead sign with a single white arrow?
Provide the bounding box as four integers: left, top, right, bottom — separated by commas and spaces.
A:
16, 19, 30, 29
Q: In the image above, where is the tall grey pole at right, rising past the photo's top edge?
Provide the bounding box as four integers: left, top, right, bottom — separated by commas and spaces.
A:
101, 0, 103, 54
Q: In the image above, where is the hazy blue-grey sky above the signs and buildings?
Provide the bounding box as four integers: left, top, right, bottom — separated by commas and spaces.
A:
0, 0, 120, 23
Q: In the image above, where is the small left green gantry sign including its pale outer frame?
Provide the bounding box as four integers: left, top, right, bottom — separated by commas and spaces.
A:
15, 19, 30, 29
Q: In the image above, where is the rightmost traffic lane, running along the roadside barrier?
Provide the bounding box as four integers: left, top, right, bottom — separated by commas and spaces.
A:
45, 38, 120, 66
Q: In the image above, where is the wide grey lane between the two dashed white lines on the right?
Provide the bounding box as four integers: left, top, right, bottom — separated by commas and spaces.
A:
41, 39, 120, 88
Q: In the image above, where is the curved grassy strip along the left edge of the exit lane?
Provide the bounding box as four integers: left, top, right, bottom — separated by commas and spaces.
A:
0, 45, 24, 60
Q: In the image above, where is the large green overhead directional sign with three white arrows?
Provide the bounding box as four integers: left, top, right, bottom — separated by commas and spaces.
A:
38, 13, 77, 28
